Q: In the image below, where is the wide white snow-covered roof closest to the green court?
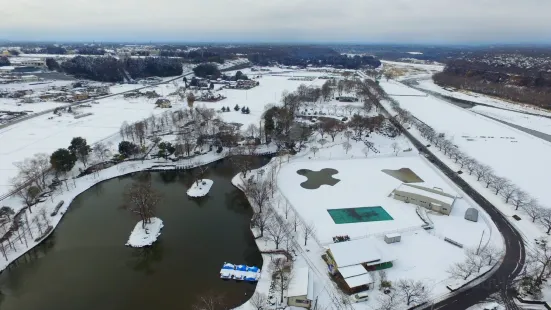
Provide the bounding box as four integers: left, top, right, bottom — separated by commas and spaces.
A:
329, 238, 396, 269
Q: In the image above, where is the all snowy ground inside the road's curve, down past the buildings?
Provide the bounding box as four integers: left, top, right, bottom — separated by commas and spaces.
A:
278, 154, 502, 296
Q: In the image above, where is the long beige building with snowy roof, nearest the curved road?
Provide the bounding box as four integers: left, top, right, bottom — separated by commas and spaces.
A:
393, 183, 455, 215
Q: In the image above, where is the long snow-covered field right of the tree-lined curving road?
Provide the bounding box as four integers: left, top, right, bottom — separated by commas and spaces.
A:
381, 81, 551, 211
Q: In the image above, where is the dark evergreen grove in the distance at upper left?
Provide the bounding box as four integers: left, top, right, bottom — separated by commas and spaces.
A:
46, 56, 183, 82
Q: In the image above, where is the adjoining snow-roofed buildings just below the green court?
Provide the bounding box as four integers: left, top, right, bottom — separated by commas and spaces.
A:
326, 238, 396, 293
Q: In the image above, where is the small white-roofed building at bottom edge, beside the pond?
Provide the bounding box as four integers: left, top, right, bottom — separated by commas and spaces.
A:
287, 267, 314, 309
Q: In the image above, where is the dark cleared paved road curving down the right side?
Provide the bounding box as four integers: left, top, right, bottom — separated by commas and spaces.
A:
381, 102, 525, 310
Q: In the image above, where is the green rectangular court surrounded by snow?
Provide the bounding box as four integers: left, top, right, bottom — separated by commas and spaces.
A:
327, 206, 394, 224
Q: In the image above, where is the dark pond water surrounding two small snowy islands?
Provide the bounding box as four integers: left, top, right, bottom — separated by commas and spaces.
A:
0, 158, 268, 310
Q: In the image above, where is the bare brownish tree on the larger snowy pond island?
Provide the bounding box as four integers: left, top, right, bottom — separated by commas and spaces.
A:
124, 177, 161, 229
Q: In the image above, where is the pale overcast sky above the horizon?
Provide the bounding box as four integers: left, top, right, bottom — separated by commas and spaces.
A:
0, 0, 551, 43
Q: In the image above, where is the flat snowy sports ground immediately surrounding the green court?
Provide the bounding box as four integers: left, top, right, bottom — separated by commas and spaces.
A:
278, 156, 448, 243
